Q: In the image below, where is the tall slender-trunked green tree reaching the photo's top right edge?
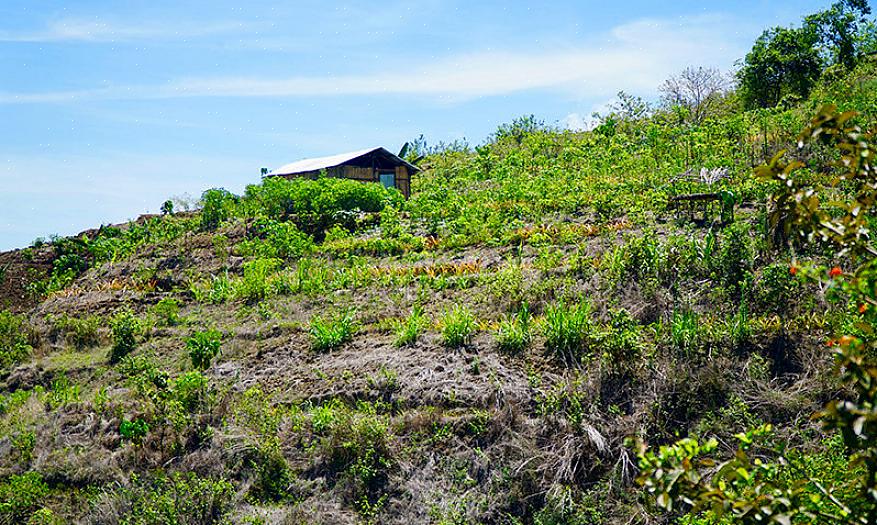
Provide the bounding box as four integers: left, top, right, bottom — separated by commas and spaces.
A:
804, 0, 871, 69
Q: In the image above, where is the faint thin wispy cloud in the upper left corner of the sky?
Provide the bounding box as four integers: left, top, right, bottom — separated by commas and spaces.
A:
0, 18, 247, 43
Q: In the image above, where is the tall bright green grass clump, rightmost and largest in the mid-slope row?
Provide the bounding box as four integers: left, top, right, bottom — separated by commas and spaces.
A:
543, 302, 591, 362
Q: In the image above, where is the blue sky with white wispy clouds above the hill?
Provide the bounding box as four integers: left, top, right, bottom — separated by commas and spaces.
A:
0, 0, 830, 250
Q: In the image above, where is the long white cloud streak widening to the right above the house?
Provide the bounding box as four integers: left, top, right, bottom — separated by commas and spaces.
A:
0, 16, 742, 104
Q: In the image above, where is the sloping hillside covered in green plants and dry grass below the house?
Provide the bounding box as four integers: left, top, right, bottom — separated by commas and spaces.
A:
0, 62, 877, 524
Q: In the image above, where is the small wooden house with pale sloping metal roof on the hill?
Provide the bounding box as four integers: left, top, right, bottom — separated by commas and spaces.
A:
265, 148, 420, 199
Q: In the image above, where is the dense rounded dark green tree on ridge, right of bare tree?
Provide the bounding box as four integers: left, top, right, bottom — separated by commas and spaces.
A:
737, 27, 823, 109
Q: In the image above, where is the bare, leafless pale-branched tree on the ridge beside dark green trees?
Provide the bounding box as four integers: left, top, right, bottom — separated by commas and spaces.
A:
659, 67, 730, 124
